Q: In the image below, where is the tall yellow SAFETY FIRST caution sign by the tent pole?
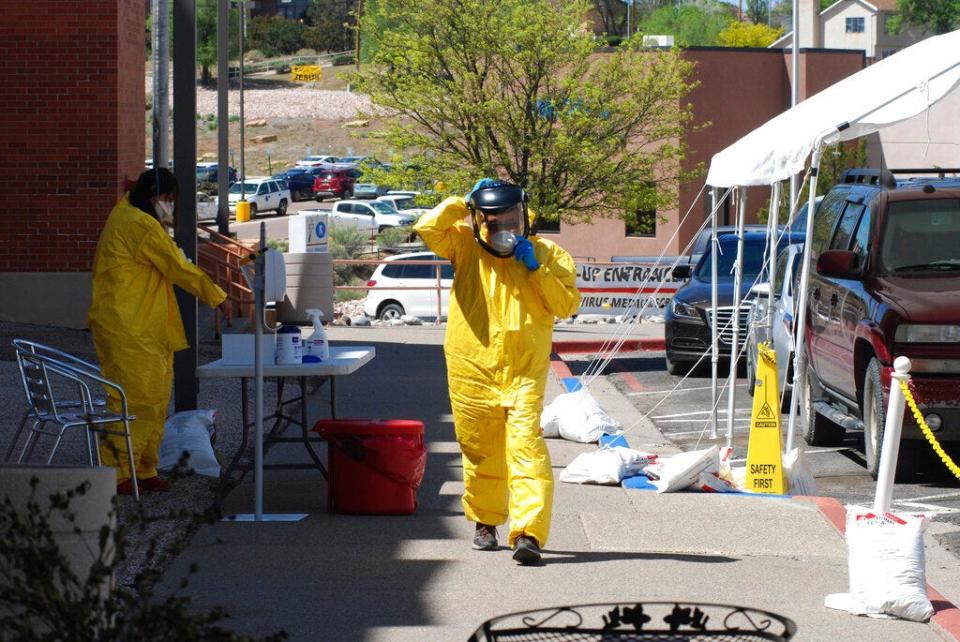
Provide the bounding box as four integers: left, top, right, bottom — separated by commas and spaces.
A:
747, 343, 787, 495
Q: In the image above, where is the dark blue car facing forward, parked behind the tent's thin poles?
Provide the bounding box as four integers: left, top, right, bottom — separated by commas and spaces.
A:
664, 231, 804, 374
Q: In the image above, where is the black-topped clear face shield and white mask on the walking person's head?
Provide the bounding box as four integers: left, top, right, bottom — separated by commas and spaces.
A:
467, 183, 530, 258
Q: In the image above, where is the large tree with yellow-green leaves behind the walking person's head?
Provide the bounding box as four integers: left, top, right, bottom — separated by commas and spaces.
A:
352, 0, 693, 221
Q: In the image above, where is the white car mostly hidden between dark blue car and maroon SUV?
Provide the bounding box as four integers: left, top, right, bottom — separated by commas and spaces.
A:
747, 243, 803, 404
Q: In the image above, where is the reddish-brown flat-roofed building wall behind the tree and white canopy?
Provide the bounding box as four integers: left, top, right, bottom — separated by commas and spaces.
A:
544, 47, 864, 261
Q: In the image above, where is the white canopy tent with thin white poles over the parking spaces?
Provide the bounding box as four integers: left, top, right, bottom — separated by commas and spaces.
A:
706, 30, 960, 451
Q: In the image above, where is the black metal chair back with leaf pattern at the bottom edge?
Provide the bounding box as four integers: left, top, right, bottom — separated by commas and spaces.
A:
469, 602, 797, 642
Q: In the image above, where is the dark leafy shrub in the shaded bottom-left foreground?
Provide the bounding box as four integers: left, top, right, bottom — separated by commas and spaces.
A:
0, 472, 287, 642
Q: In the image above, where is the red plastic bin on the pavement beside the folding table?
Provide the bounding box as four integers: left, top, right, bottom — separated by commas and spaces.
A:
313, 419, 427, 515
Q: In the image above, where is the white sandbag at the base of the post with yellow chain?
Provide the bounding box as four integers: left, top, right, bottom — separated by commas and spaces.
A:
830, 506, 933, 622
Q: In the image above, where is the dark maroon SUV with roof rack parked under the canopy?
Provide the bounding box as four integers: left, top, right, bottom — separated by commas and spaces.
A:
798, 169, 960, 477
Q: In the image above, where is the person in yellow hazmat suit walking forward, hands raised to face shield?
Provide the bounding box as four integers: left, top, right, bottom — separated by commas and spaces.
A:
414, 179, 580, 564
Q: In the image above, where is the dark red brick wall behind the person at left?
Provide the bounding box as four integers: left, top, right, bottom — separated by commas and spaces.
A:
0, 0, 145, 272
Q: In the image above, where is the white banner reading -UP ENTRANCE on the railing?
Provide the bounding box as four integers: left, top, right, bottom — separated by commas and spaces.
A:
577, 257, 684, 316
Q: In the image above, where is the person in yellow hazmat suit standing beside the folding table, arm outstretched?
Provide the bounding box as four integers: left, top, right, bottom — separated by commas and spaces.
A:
87, 168, 227, 494
